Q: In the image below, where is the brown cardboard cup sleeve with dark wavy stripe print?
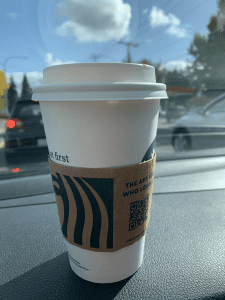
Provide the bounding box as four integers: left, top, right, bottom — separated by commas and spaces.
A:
48, 155, 156, 252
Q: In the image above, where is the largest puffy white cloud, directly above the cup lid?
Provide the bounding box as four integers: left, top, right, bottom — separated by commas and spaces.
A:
56, 0, 131, 42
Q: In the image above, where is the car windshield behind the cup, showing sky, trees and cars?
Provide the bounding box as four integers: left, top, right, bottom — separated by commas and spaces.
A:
0, 0, 225, 179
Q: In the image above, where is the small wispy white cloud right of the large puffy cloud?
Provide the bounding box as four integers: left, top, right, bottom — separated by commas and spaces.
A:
149, 6, 189, 38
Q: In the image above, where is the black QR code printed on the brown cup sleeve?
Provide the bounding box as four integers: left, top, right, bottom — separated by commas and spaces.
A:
129, 196, 149, 231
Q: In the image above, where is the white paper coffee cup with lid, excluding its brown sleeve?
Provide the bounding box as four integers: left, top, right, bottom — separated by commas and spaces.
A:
32, 63, 168, 283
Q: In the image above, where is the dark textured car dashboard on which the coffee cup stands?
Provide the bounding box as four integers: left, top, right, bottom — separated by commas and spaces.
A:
0, 156, 225, 300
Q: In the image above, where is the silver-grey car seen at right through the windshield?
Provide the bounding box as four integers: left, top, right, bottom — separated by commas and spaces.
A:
172, 93, 225, 152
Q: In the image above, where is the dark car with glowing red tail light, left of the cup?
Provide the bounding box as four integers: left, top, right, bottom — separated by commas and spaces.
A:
4, 98, 47, 162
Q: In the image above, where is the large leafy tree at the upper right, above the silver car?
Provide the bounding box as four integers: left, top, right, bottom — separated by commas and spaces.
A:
188, 0, 225, 90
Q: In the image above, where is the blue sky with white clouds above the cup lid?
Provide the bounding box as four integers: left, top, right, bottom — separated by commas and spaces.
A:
0, 0, 218, 93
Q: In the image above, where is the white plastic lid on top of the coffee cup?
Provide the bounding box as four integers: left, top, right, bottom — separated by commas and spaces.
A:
32, 63, 168, 101
